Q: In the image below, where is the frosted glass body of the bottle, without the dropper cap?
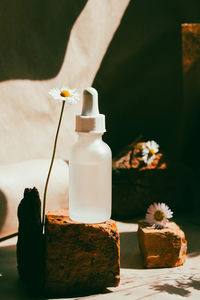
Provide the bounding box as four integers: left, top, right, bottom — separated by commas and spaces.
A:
69, 133, 111, 223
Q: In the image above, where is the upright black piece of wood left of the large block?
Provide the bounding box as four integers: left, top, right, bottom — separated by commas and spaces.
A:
17, 187, 44, 290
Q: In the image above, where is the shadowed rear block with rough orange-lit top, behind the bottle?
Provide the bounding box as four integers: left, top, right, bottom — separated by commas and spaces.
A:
112, 142, 193, 219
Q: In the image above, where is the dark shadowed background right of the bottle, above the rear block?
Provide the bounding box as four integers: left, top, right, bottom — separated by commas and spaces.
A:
94, 0, 200, 171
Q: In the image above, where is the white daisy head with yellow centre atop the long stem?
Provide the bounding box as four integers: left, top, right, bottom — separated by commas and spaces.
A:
49, 86, 80, 104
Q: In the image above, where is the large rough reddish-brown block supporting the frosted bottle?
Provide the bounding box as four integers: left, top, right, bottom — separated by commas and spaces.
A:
45, 210, 120, 295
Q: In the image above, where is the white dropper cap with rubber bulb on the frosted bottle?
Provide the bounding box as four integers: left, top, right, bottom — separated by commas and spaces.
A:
76, 87, 106, 133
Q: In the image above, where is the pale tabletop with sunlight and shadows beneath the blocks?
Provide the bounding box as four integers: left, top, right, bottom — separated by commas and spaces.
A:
0, 216, 200, 300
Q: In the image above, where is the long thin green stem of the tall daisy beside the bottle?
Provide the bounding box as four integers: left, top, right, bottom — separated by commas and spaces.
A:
42, 101, 65, 232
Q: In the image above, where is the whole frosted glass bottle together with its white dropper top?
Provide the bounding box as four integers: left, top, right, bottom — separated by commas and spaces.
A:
69, 88, 112, 223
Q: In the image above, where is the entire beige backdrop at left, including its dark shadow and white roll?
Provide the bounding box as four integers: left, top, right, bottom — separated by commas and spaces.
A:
0, 0, 129, 238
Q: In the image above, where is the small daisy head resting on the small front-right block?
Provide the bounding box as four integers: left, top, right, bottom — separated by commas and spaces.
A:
145, 203, 173, 228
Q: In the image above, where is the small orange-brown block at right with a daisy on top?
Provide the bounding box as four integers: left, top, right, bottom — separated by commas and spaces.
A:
138, 220, 187, 268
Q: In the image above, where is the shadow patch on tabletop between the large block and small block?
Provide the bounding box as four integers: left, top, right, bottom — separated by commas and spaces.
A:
120, 232, 143, 269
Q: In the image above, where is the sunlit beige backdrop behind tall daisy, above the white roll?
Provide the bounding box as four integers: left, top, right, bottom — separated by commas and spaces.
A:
0, 0, 129, 164
